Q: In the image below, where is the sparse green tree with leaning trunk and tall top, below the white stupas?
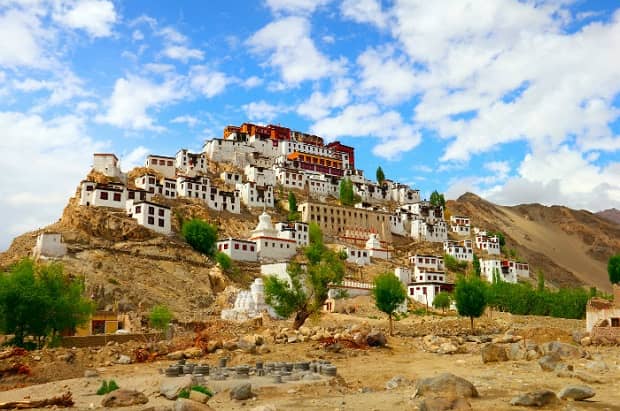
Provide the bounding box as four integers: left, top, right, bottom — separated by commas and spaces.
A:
265, 223, 345, 329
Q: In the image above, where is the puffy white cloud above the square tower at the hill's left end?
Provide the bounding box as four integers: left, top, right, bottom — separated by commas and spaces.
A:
96, 76, 187, 131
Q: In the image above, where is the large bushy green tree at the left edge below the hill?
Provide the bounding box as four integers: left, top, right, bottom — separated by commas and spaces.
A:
0, 259, 94, 347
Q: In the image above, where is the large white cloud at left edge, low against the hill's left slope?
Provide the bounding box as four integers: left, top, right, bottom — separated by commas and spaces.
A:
0, 112, 104, 249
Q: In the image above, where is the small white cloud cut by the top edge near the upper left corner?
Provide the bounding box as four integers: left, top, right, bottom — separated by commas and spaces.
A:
53, 0, 117, 37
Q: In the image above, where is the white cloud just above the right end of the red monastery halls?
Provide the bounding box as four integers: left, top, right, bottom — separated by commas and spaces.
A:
310, 103, 421, 159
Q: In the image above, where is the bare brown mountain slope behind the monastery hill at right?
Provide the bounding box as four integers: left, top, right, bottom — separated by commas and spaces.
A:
447, 193, 620, 292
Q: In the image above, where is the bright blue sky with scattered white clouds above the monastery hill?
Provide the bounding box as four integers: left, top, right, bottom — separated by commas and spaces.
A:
0, 0, 620, 249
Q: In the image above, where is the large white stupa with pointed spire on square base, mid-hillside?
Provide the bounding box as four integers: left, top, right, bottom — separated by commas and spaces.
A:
250, 212, 297, 261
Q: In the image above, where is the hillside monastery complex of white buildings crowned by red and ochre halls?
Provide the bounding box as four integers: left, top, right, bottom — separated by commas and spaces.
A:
61, 123, 529, 317
